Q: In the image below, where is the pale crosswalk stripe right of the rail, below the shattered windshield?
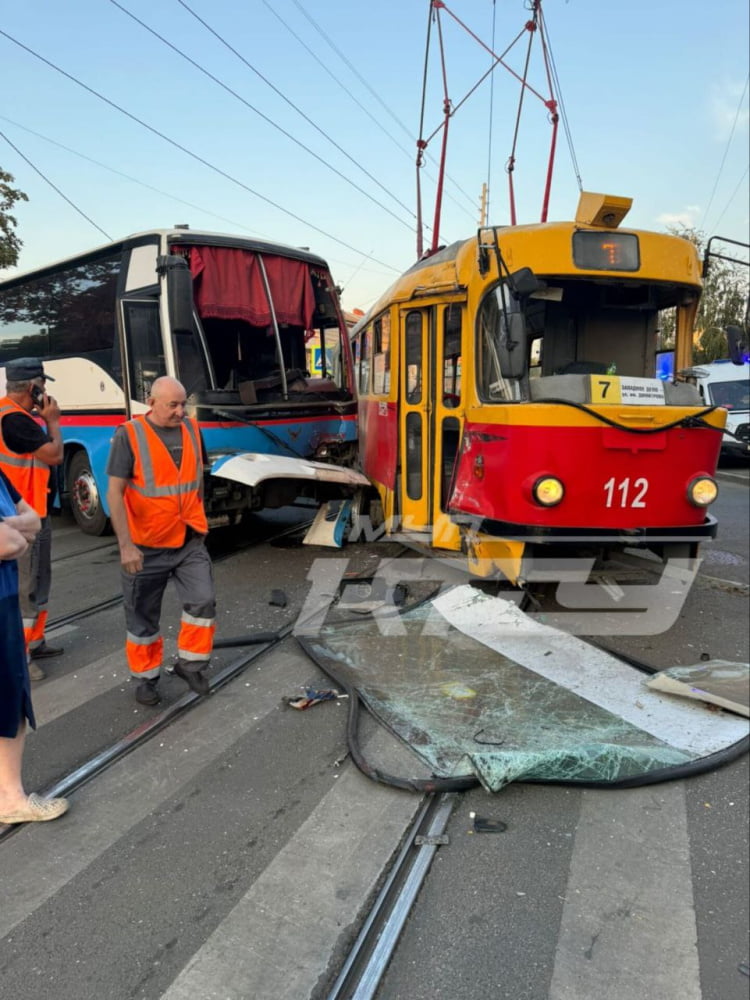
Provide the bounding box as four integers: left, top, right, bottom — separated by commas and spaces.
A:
549, 783, 701, 1000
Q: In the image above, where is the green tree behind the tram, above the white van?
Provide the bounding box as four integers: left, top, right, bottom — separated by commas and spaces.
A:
669, 227, 748, 364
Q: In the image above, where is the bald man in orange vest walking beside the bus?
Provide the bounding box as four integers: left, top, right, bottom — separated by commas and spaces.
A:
107, 376, 216, 705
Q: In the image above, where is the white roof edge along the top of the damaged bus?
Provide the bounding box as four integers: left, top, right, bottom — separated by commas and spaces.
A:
0, 226, 329, 288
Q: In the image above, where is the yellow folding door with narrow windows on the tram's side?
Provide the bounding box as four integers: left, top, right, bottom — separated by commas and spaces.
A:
399, 303, 463, 549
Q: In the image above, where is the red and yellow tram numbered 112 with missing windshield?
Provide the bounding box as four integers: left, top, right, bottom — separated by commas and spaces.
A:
352, 192, 726, 585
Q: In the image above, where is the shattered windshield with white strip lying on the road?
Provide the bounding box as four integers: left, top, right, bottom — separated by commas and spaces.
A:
303, 585, 748, 791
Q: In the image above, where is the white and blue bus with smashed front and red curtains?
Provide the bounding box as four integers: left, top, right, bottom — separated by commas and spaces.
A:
0, 226, 362, 535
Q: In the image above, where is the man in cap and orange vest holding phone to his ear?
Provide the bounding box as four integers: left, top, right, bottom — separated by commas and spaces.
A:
0, 358, 63, 681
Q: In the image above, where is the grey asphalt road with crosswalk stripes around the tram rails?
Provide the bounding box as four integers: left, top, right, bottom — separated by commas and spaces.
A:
0, 478, 750, 1000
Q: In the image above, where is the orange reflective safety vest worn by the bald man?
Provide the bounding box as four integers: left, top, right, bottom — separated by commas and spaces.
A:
124, 416, 208, 549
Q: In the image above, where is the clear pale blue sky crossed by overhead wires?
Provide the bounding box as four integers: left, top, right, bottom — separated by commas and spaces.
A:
0, 0, 750, 310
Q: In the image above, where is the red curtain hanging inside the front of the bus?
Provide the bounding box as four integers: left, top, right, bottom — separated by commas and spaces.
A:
189, 246, 315, 332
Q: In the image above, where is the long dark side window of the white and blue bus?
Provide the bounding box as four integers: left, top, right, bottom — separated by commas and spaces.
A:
0, 253, 122, 385
